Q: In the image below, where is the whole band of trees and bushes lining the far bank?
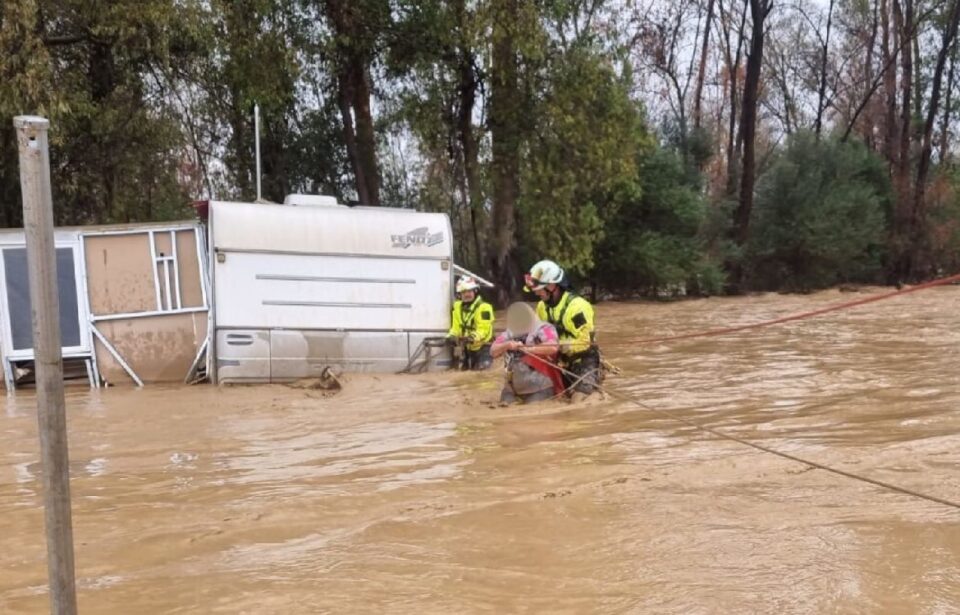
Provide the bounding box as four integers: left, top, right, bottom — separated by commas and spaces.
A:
0, 0, 960, 300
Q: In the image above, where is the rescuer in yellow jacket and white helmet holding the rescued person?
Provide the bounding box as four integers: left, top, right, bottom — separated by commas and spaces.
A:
525, 260, 602, 401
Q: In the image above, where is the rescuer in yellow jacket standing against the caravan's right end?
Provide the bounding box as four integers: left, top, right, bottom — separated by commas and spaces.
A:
447, 277, 494, 371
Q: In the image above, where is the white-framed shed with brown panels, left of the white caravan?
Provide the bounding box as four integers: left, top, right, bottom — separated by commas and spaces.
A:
0, 221, 209, 390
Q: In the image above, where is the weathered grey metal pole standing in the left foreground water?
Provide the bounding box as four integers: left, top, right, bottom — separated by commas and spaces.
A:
13, 116, 77, 615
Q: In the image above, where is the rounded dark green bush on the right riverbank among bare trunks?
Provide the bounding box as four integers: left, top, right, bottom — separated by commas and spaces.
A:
744, 133, 890, 291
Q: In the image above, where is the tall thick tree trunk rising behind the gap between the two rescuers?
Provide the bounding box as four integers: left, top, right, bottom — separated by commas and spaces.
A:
489, 0, 522, 303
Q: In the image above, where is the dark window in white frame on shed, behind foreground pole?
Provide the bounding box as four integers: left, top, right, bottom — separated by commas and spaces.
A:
3, 248, 82, 351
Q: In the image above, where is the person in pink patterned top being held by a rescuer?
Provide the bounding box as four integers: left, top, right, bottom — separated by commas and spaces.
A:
490, 303, 564, 404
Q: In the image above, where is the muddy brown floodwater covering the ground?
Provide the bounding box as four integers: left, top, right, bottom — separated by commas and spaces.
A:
0, 288, 960, 615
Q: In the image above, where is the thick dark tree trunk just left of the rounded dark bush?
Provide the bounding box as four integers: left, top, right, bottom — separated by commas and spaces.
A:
733, 0, 770, 258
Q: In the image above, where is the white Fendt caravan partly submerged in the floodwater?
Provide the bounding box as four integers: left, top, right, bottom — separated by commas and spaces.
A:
207, 195, 454, 383
